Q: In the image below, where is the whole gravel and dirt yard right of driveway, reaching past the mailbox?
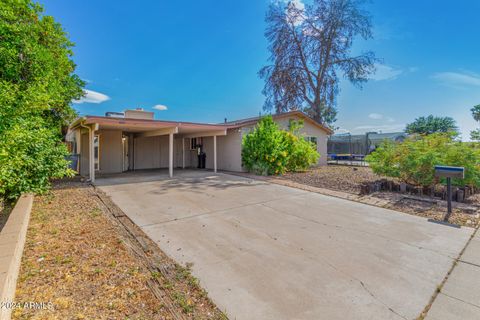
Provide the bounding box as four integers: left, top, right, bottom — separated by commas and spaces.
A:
275, 165, 480, 227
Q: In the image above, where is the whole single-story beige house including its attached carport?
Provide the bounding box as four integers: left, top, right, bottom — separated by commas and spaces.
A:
67, 109, 332, 180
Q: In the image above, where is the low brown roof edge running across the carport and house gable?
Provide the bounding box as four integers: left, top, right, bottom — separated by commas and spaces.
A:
70, 111, 333, 134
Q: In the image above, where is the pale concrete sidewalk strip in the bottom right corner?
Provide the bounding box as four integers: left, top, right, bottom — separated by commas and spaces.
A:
425, 231, 480, 320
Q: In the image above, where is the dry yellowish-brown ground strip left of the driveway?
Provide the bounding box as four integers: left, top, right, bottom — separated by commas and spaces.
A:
13, 182, 225, 319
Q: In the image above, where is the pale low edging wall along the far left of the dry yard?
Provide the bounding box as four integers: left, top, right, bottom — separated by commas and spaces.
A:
0, 194, 33, 320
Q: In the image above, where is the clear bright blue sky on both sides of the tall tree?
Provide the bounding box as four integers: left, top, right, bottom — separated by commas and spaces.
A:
41, 0, 480, 138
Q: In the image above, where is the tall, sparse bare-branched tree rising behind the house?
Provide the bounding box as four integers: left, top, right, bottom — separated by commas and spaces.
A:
259, 0, 376, 126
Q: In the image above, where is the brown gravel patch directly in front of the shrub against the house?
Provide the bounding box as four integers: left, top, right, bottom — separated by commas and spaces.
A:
280, 165, 392, 194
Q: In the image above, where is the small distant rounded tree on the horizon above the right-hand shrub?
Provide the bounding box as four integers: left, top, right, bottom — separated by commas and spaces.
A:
405, 115, 458, 135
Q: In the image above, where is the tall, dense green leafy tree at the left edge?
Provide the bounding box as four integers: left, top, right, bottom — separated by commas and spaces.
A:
0, 0, 84, 198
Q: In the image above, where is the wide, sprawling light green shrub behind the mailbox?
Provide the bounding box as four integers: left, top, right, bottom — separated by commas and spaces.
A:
366, 133, 480, 187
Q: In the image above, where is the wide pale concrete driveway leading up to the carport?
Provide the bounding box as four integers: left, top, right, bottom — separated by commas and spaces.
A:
97, 171, 473, 319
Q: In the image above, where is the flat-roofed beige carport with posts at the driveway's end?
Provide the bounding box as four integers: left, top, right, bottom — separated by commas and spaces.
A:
71, 116, 229, 182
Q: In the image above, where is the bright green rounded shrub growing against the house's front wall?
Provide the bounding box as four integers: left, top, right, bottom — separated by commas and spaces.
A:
242, 116, 320, 175
